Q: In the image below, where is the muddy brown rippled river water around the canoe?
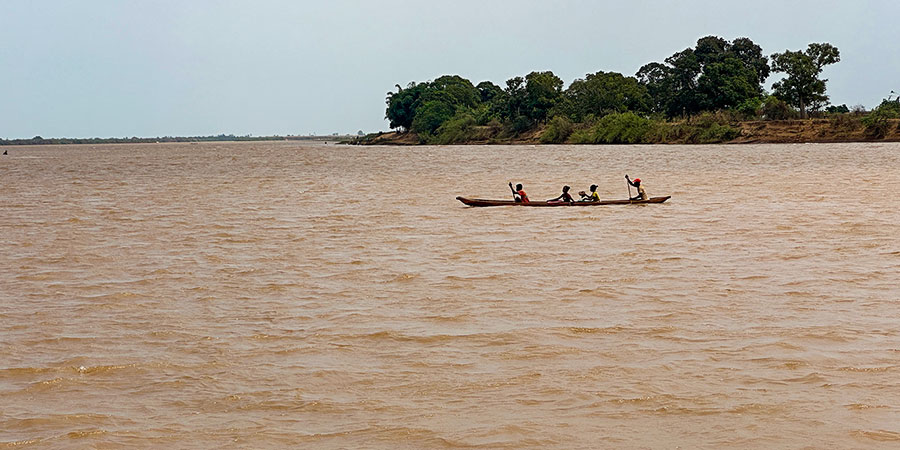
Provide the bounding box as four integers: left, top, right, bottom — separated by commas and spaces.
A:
0, 142, 900, 449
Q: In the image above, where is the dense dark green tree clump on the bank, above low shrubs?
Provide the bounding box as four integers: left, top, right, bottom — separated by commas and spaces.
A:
385, 36, 840, 140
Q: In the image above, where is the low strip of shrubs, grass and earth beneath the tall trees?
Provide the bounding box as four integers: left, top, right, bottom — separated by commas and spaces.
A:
351, 102, 900, 145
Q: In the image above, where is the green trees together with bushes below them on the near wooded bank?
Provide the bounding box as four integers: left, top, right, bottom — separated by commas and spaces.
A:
385, 36, 900, 144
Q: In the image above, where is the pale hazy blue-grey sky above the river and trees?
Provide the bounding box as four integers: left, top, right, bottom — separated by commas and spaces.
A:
0, 0, 900, 138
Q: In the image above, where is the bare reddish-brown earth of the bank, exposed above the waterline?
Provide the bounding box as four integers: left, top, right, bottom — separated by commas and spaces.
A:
349, 117, 900, 145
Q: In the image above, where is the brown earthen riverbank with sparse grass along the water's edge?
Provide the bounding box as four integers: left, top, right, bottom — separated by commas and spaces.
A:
350, 116, 900, 145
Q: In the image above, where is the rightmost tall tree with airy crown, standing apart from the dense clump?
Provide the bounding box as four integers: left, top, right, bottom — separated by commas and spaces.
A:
772, 43, 841, 119
